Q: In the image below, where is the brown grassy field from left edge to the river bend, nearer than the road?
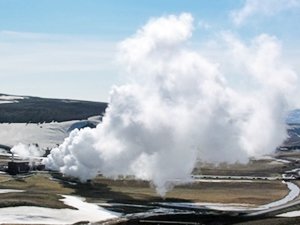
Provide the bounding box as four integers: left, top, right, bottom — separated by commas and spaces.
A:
0, 173, 288, 208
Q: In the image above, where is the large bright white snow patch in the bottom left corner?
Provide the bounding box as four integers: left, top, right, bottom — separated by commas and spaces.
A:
0, 195, 119, 224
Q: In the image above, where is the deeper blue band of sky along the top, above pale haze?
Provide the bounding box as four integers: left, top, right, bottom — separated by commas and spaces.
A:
0, 0, 238, 36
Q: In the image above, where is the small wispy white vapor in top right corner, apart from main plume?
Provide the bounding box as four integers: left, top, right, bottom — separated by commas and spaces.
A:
231, 0, 300, 25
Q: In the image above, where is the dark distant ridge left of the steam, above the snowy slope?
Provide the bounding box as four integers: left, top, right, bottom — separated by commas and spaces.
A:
0, 94, 107, 123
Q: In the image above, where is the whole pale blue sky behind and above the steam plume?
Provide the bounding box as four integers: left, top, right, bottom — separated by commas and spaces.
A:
0, 0, 300, 101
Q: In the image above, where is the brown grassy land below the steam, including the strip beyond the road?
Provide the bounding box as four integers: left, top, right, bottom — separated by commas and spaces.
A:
0, 149, 300, 220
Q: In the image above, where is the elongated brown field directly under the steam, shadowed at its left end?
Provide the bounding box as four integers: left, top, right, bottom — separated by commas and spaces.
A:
59, 177, 288, 205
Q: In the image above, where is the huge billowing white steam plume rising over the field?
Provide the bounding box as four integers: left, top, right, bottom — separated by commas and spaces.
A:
40, 13, 297, 195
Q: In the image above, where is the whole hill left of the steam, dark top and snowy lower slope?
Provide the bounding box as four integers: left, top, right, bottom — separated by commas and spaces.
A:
0, 94, 107, 149
